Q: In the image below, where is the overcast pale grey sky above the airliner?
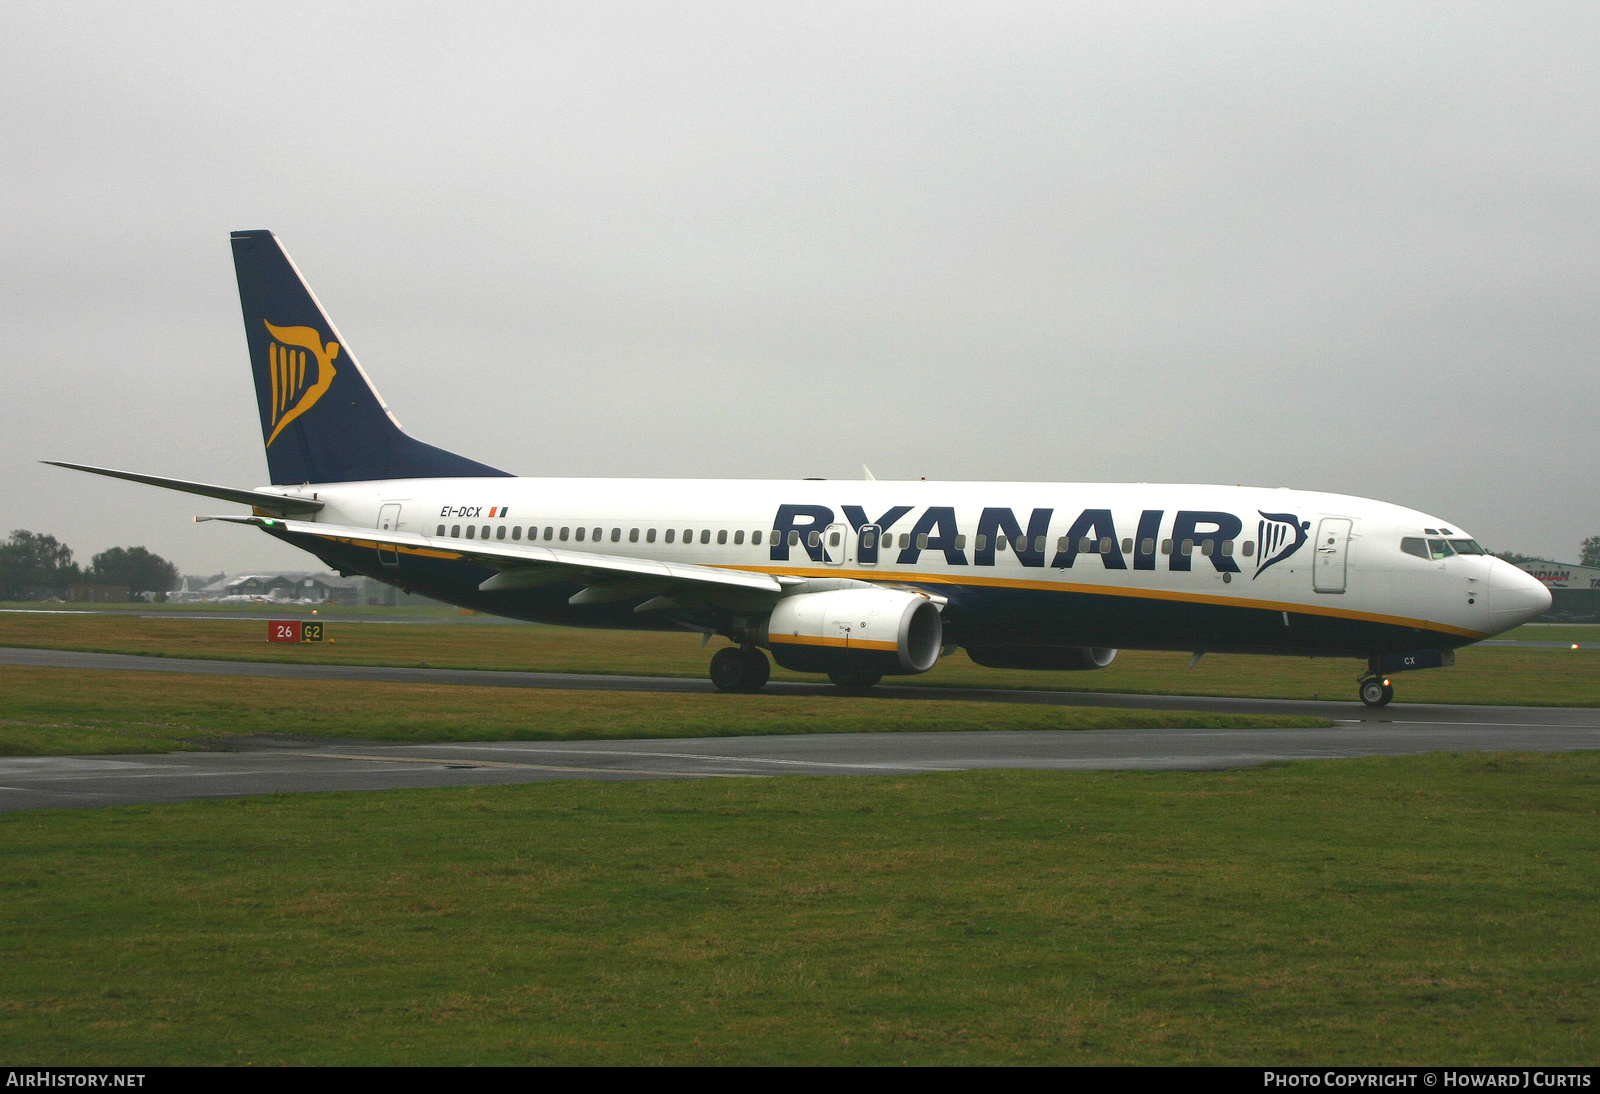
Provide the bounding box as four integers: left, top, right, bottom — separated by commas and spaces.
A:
0, 0, 1600, 573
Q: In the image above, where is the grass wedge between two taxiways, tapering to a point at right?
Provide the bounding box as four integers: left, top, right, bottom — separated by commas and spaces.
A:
0, 665, 1333, 757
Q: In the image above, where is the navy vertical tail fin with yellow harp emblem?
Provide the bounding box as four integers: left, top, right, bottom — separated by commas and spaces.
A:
234, 232, 509, 485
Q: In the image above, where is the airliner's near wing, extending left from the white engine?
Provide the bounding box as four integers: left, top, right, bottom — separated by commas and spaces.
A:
195, 515, 790, 606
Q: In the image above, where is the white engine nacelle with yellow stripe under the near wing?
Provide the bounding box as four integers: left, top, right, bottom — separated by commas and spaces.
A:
766, 589, 944, 675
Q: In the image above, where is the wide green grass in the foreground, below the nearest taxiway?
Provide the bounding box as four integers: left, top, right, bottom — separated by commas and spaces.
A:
0, 753, 1600, 1067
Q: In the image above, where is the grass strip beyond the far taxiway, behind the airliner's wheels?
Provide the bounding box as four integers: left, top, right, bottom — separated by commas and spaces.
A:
0, 609, 1600, 707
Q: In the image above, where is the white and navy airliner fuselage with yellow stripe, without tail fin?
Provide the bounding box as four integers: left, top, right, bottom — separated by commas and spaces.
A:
266, 478, 1549, 657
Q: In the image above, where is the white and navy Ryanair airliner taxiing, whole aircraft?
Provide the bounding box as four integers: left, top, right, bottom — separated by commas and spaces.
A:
58, 232, 1550, 705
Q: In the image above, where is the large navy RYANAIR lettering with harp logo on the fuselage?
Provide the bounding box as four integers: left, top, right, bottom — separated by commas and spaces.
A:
770, 505, 1310, 576
